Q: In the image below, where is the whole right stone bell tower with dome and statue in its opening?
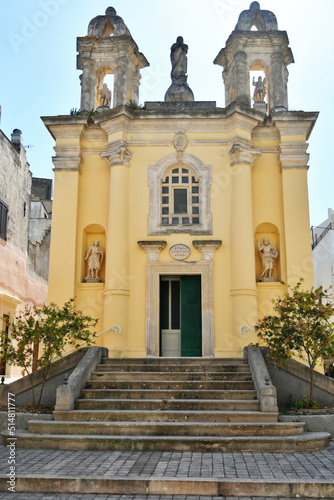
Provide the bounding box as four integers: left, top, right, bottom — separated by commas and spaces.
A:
214, 2, 294, 112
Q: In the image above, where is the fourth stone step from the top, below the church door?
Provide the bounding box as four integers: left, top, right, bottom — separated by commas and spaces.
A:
86, 380, 254, 391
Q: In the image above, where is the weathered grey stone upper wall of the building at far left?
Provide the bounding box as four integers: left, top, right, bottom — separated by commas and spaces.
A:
0, 130, 31, 255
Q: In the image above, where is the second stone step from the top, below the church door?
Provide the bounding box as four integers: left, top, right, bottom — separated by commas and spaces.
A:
96, 364, 249, 373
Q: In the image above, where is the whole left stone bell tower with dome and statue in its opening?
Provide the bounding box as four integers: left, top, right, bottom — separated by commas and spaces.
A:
77, 7, 149, 111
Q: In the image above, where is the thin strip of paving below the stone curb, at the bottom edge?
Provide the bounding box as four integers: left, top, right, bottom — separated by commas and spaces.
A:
0, 493, 328, 500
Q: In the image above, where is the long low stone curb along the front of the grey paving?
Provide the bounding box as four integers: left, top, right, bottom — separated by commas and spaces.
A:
0, 474, 333, 499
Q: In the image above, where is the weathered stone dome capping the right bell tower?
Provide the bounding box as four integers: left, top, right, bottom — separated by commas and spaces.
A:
235, 2, 278, 31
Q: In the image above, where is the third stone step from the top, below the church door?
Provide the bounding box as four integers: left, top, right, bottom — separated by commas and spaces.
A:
91, 371, 252, 381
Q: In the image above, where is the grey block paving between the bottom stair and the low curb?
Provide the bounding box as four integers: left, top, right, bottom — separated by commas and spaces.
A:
0, 442, 334, 482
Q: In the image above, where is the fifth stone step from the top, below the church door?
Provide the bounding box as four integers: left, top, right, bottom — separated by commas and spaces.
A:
81, 389, 256, 400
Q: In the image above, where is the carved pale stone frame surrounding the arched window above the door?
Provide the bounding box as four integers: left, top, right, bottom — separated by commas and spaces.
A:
148, 153, 212, 235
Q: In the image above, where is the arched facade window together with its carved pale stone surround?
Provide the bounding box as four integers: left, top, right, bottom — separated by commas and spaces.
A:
148, 153, 212, 234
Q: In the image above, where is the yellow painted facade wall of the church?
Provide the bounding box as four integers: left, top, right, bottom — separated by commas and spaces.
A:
49, 111, 312, 357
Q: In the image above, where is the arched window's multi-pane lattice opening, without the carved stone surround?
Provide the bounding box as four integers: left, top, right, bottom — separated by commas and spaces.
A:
161, 166, 200, 226
